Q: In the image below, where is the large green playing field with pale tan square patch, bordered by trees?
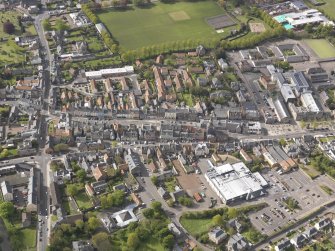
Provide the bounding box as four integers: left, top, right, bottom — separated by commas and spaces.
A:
97, 1, 235, 49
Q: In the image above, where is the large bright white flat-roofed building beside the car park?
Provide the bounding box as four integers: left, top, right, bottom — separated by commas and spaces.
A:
205, 162, 268, 204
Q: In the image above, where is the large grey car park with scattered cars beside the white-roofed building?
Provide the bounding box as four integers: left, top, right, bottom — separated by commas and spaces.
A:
249, 169, 335, 235
